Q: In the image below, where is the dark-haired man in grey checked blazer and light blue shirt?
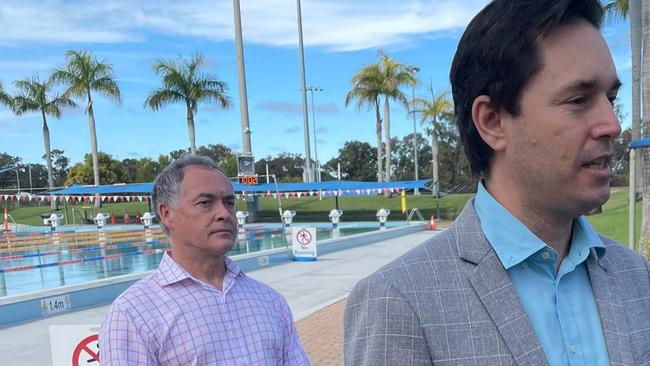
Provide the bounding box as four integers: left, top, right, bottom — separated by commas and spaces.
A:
344, 0, 650, 366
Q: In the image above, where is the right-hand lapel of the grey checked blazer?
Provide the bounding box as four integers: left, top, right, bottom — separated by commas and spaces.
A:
587, 249, 633, 365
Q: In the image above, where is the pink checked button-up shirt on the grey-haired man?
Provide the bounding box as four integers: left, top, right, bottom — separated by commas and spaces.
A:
99, 253, 310, 366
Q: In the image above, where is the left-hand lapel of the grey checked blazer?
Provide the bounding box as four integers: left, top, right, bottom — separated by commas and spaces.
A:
450, 200, 548, 366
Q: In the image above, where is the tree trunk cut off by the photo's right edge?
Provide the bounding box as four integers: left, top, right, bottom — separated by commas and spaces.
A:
640, 0, 650, 252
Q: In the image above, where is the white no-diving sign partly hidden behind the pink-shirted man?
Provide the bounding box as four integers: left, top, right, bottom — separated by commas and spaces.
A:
50, 325, 99, 366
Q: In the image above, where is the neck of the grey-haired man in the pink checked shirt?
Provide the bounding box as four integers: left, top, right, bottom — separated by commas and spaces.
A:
171, 242, 226, 290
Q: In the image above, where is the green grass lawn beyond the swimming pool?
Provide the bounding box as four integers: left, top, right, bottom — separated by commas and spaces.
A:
0, 188, 641, 244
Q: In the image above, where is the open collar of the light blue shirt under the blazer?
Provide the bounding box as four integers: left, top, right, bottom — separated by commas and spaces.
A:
474, 182, 605, 269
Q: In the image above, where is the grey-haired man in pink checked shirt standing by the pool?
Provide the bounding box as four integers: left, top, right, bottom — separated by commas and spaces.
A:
99, 155, 310, 366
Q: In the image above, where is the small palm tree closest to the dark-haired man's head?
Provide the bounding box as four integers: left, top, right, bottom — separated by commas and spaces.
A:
411, 83, 454, 196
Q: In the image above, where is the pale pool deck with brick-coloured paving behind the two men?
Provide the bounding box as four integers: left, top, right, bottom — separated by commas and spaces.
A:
0, 227, 436, 366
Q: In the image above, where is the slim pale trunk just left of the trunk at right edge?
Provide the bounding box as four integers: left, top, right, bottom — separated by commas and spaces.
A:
628, 0, 643, 192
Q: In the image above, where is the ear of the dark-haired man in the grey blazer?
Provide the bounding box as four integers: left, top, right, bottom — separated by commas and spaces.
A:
472, 95, 506, 151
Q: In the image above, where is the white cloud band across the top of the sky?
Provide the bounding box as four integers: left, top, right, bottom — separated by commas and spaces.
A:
0, 0, 487, 51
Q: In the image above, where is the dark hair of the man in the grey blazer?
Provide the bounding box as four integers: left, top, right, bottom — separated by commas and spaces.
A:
449, 0, 603, 176
